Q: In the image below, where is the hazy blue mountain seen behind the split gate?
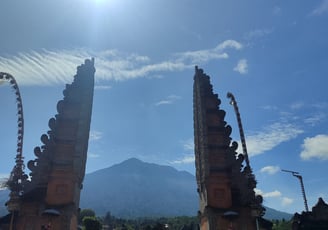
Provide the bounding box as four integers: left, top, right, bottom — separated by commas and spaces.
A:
80, 158, 291, 219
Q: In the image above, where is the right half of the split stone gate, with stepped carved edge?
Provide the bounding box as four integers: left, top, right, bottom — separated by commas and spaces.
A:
194, 67, 264, 230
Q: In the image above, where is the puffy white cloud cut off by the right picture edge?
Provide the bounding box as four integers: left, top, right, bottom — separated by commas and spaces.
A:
300, 134, 328, 160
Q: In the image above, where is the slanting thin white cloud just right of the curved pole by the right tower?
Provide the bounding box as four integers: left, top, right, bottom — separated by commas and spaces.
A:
246, 122, 303, 156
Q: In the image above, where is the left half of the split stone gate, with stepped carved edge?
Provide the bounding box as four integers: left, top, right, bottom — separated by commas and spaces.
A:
0, 59, 95, 230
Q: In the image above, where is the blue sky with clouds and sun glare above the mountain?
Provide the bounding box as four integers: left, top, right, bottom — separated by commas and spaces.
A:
0, 0, 328, 213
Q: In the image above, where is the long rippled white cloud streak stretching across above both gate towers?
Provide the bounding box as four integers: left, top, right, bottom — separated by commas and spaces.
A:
0, 40, 243, 86
